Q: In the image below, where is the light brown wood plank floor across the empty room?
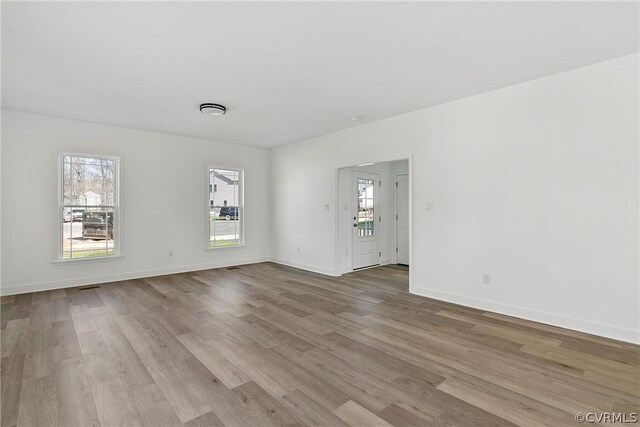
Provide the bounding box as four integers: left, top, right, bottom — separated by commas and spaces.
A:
1, 263, 640, 427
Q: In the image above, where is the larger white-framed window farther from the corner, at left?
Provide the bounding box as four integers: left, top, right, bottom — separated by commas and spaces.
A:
59, 153, 119, 260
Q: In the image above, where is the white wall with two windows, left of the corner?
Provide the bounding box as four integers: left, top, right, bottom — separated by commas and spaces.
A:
1, 110, 270, 294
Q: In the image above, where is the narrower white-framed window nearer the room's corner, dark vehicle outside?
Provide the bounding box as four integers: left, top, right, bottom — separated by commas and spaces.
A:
207, 167, 244, 248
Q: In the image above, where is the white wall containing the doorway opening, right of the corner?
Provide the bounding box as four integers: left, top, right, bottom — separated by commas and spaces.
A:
271, 54, 640, 342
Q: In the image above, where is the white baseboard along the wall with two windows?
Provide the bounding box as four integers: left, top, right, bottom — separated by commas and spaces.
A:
0, 257, 270, 296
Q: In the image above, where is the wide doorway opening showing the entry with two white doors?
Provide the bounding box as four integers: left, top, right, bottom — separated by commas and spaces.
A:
337, 159, 410, 274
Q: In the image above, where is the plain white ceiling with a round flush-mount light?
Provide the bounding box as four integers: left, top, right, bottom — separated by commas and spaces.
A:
2, 1, 639, 147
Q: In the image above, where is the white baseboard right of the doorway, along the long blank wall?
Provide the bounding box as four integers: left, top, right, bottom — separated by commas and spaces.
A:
410, 287, 640, 344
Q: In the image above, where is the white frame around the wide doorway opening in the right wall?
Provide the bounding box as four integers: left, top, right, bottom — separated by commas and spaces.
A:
326, 153, 414, 292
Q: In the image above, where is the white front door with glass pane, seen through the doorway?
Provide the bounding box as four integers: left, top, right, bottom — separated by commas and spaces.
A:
352, 172, 380, 270
